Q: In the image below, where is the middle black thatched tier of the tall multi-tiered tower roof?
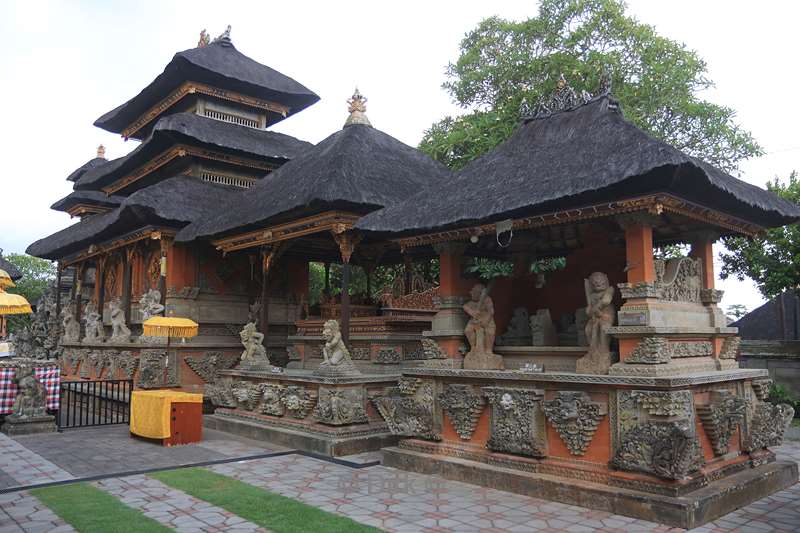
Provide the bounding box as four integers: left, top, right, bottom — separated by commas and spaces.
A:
75, 113, 313, 190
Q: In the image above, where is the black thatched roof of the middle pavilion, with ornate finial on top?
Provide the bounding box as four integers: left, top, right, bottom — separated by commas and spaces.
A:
177, 124, 450, 241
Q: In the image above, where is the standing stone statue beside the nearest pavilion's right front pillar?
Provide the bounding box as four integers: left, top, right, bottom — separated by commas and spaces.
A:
577, 272, 616, 374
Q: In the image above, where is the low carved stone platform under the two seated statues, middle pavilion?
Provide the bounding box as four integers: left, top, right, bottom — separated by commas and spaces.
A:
205, 369, 399, 457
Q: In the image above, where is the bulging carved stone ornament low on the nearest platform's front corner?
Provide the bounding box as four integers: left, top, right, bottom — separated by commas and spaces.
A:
611, 420, 705, 479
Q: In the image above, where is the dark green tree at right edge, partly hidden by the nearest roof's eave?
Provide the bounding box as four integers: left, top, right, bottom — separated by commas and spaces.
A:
720, 172, 800, 298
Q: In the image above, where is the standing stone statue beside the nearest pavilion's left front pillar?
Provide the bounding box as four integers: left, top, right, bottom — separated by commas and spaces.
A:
464, 283, 503, 370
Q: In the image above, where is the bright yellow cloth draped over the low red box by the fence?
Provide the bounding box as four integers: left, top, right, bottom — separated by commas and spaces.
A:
131, 390, 203, 439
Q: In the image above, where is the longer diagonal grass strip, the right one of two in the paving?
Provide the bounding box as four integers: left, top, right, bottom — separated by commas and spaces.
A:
153, 468, 381, 533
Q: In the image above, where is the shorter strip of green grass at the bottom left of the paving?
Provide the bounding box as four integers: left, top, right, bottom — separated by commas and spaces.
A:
30, 483, 172, 533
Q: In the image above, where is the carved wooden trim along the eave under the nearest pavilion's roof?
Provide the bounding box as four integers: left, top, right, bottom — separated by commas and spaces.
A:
393, 194, 764, 251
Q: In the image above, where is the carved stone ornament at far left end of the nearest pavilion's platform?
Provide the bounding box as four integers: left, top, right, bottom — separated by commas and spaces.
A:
372, 378, 442, 440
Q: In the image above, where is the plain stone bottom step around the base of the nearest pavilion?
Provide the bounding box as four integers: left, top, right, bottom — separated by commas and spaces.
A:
383, 441, 798, 529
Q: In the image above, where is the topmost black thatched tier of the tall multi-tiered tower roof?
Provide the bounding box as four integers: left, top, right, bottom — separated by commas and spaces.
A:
94, 40, 319, 133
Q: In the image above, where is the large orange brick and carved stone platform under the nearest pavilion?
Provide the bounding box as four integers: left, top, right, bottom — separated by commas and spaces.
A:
373, 368, 798, 527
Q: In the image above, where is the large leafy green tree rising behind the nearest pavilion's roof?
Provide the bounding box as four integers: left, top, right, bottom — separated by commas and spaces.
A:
420, 0, 762, 171
